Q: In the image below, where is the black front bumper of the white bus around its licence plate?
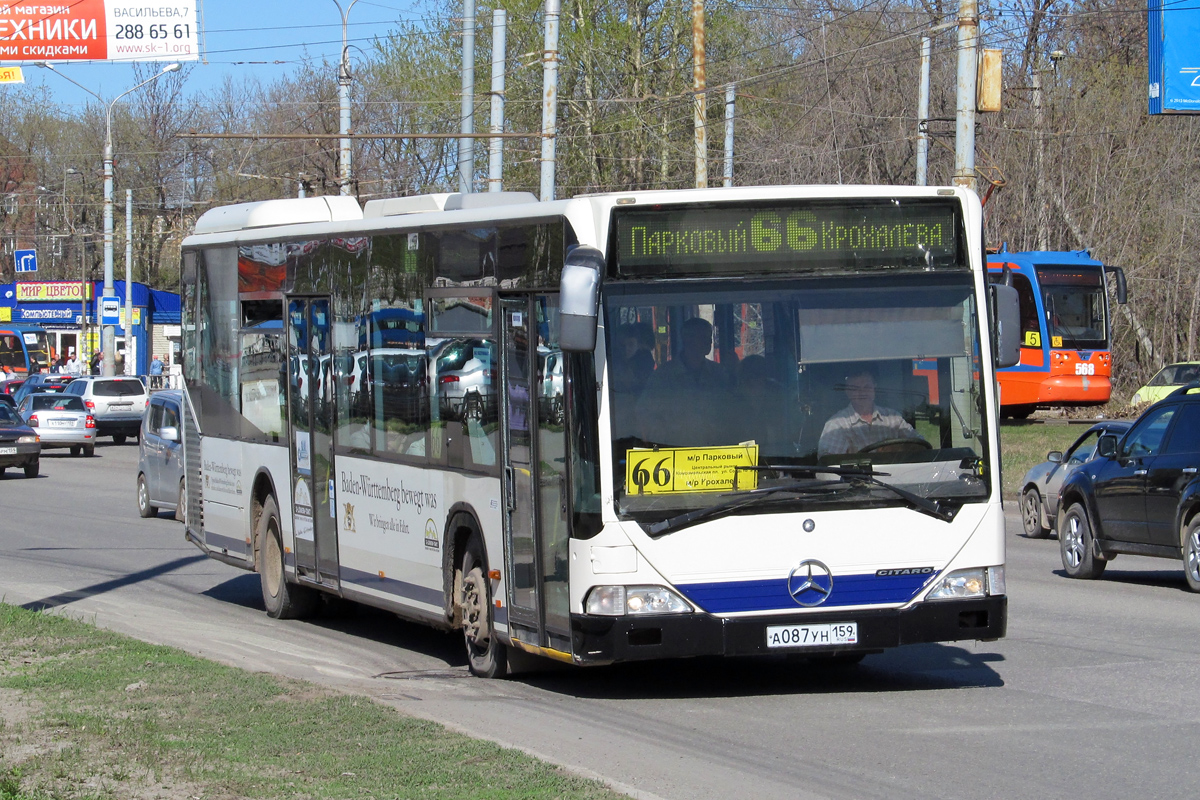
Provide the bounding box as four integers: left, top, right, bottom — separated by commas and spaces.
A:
571, 596, 1008, 664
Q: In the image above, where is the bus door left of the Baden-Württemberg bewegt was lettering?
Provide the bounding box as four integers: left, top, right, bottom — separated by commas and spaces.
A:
280, 297, 338, 589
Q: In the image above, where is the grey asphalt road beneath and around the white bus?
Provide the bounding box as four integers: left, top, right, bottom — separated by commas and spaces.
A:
0, 444, 1200, 800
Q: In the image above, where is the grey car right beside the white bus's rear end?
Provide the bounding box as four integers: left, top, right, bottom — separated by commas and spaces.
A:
138, 390, 187, 519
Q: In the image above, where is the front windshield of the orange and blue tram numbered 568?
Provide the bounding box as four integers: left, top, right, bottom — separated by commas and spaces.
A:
1037, 266, 1109, 350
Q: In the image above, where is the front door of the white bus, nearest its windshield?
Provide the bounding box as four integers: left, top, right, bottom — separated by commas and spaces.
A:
500, 295, 570, 654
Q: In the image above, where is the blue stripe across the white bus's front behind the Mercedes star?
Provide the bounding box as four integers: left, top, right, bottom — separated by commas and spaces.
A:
676, 573, 938, 614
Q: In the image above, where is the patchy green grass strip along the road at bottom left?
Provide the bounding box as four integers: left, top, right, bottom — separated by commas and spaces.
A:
0, 603, 620, 800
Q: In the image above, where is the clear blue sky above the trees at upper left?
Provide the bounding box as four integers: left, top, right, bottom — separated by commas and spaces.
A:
23, 0, 421, 108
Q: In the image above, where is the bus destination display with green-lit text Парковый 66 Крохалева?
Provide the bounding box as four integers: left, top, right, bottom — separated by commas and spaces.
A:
617, 201, 958, 276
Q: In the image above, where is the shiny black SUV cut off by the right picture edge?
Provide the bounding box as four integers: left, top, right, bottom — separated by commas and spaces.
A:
1058, 383, 1200, 591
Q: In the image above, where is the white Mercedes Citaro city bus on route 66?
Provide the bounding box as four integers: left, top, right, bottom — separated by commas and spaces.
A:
182, 186, 1018, 676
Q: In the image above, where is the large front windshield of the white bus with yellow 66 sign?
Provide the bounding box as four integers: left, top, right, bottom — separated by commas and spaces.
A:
605, 272, 990, 522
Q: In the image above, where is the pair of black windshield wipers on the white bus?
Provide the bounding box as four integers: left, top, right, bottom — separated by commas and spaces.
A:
646, 464, 956, 537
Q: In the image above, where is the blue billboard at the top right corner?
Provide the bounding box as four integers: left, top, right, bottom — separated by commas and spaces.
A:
1147, 0, 1200, 114
